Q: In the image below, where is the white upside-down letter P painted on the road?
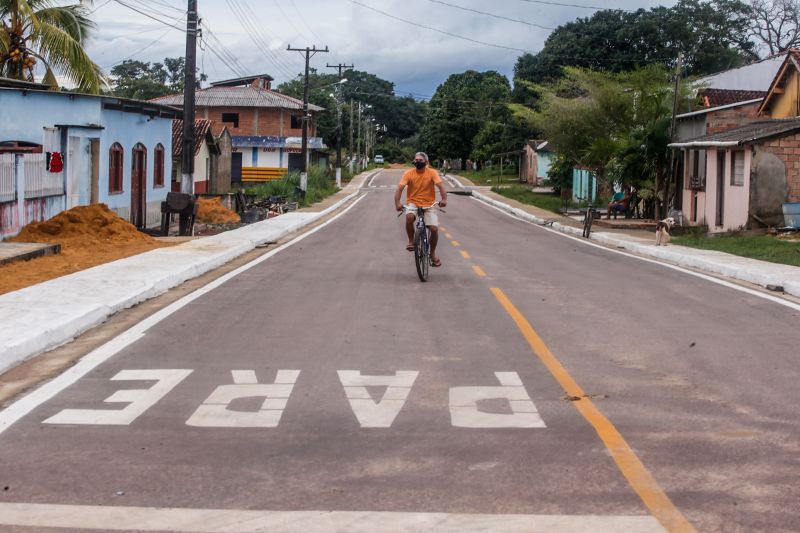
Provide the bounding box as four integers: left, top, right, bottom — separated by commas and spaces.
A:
450, 372, 547, 428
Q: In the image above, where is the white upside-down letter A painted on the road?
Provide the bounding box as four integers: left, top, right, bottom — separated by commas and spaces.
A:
338, 370, 419, 428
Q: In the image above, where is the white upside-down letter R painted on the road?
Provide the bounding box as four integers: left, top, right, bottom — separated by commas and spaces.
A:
186, 370, 300, 428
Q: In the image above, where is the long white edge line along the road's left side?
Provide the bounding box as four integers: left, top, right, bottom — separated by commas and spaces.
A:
0, 193, 366, 434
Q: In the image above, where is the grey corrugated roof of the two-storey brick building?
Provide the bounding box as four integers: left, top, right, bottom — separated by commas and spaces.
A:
152, 87, 325, 111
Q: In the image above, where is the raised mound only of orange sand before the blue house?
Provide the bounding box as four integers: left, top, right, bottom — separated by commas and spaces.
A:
9, 204, 153, 247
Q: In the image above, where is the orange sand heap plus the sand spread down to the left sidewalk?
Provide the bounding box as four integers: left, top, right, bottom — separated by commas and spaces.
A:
0, 204, 172, 294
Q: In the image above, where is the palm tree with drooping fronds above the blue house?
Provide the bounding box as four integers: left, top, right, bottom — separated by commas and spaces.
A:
0, 0, 105, 94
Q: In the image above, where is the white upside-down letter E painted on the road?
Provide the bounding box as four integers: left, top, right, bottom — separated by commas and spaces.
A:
44, 369, 192, 426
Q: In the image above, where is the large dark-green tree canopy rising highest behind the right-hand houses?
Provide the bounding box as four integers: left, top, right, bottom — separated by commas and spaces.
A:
514, 0, 757, 90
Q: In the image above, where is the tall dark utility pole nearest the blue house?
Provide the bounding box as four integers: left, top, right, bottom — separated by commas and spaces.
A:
181, 0, 197, 194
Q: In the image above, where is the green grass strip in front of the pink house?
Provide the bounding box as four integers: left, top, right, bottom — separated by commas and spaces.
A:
672, 234, 800, 266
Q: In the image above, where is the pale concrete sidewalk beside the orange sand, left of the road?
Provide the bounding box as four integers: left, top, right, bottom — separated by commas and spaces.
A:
0, 173, 371, 373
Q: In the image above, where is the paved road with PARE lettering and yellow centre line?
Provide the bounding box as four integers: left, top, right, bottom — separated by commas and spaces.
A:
0, 171, 800, 532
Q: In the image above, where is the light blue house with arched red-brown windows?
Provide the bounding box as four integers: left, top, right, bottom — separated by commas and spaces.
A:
0, 79, 181, 237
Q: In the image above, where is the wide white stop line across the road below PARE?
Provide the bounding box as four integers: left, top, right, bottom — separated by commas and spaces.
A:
0, 503, 664, 533
